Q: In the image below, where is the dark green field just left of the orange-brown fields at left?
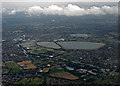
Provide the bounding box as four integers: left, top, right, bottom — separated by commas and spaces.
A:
5, 62, 21, 74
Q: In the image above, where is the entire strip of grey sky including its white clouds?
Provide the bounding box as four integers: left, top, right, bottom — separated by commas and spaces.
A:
2, 2, 118, 16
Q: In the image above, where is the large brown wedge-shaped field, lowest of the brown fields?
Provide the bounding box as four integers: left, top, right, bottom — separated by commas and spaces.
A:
51, 72, 79, 80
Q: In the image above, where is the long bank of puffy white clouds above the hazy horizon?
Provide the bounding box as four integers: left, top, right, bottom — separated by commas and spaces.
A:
3, 4, 118, 16
